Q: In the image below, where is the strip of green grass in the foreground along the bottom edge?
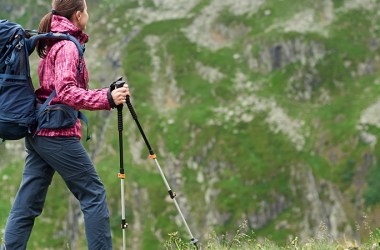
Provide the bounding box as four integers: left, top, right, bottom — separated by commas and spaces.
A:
163, 222, 380, 250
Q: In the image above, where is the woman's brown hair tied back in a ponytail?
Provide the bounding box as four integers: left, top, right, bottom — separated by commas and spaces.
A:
37, 0, 85, 58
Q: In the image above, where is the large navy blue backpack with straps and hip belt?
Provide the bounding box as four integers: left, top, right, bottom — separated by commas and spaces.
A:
0, 20, 89, 141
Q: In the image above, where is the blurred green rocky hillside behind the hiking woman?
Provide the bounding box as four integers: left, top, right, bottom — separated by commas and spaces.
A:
0, 0, 380, 249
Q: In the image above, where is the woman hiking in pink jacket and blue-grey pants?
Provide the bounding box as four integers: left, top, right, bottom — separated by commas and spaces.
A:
2, 0, 130, 250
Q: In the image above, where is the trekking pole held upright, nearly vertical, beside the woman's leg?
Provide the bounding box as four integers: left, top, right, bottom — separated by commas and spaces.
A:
115, 78, 128, 250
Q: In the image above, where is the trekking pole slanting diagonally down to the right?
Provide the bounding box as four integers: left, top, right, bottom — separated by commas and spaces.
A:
126, 87, 198, 249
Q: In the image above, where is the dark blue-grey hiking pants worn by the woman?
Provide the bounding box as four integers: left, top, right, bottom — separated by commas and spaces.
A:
1, 136, 112, 250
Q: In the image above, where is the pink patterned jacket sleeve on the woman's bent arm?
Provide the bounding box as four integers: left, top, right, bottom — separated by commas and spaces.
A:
54, 41, 111, 110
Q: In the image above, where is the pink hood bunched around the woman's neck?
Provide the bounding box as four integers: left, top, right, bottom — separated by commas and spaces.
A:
50, 15, 88, 44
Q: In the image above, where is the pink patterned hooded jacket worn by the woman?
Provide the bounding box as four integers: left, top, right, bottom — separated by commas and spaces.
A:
36, 15, 111, 139
